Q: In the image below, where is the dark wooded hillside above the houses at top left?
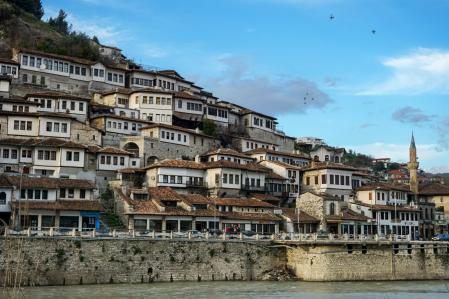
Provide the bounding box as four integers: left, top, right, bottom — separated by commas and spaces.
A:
0, 0, 99, 60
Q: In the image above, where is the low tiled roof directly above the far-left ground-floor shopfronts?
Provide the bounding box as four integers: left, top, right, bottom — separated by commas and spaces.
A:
11, 200, 103, 212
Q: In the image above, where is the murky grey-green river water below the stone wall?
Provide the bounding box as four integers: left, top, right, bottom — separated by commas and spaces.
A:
19, 281, 449, 299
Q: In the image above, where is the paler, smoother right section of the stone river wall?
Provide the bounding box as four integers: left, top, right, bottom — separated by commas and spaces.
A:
287, 242, 449, 281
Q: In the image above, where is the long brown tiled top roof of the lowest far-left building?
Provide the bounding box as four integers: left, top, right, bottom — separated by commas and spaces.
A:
7, 175, 96, 189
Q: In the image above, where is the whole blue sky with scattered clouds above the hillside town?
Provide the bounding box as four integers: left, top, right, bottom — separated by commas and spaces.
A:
42, 0, 449, 173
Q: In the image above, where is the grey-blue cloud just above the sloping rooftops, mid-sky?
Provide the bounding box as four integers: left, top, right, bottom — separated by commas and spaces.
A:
201, 55, 332, 115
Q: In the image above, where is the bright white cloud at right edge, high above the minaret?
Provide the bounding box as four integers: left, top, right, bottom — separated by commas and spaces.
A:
357, 48, 449, 95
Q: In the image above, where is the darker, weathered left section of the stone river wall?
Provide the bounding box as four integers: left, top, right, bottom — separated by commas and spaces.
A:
0, 238, 285, 285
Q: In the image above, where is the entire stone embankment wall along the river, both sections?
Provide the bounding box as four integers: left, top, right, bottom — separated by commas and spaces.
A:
0, 237, 449, 286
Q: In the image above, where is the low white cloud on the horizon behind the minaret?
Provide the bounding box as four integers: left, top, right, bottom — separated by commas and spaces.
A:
345, 142, 449, 172
